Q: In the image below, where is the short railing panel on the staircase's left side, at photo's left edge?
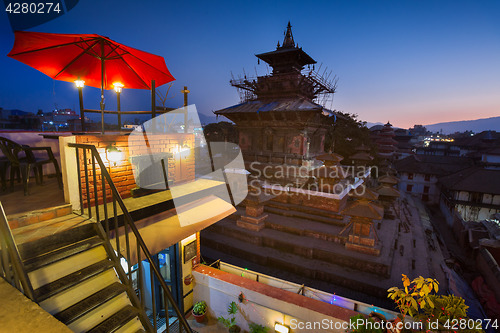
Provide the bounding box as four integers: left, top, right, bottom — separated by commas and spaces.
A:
0, 202, 34, 300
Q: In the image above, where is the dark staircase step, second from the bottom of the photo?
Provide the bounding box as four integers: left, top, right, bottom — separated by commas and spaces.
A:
54, 282, 127, 325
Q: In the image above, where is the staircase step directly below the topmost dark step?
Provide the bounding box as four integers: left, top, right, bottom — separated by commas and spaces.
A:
24, 236, 103, 272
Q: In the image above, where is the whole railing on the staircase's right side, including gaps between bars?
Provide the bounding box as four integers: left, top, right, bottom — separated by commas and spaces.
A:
68, 143, 192, 333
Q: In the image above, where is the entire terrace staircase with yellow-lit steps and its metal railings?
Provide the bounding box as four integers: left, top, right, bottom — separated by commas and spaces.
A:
0, 144, 192, 333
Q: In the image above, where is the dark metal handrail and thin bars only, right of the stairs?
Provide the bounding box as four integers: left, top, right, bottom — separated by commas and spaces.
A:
68, 143, 192, 333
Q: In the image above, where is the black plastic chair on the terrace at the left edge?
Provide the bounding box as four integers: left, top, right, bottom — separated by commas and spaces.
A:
0, 137, 62, 195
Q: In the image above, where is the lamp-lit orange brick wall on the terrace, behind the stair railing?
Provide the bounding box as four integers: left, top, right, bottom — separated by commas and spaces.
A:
76, 133, 195, 207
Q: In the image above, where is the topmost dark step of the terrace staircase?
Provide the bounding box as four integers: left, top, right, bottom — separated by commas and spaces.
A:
16, 223, 96, 260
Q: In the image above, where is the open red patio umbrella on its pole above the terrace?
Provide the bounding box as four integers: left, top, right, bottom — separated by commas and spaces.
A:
8, 31, 175, 132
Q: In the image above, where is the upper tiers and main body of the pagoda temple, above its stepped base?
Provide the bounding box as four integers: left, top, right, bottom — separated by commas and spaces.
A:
214, 22, 336, 185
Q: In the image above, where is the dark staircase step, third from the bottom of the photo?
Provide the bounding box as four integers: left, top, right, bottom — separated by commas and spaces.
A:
35, 260, 113, 302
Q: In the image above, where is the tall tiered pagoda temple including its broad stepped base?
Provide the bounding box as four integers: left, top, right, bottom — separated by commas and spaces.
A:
201, 24, 427, 302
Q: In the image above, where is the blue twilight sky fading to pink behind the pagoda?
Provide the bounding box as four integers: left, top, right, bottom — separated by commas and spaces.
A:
0, 0, 500, 127
